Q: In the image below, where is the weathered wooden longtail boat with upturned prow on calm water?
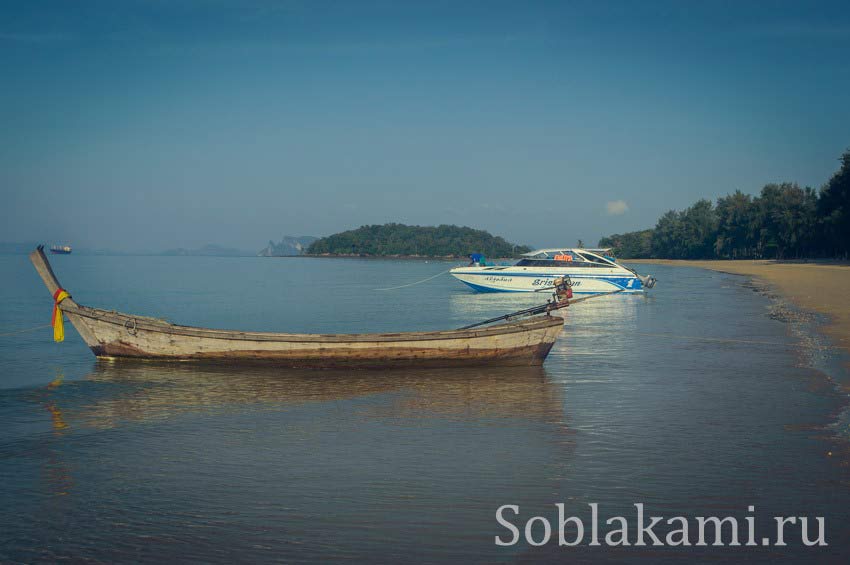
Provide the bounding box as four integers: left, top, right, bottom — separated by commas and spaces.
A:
30, 246, 564, 368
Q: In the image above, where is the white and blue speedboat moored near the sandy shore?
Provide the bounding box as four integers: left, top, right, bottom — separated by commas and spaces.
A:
451, 248, 655, 294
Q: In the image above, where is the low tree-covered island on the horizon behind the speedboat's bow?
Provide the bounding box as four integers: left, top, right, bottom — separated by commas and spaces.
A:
306, 223, 531, 257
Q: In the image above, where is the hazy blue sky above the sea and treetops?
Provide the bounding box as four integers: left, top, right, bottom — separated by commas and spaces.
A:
0, 0, 850, 250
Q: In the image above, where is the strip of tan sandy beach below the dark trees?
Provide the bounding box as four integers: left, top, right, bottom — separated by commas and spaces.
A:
625, 259, 850, 360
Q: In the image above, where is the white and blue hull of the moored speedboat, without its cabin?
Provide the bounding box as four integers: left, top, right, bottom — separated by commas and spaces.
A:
451, 267, 643, 294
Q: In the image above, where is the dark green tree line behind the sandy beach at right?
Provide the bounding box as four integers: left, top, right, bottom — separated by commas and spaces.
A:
599, 150, 850, 259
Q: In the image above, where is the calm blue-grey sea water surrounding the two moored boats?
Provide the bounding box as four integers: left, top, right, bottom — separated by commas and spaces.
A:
0, 256, 850, 562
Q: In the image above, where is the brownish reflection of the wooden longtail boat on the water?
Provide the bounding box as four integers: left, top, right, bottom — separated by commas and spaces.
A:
46, 361, 563, 428
